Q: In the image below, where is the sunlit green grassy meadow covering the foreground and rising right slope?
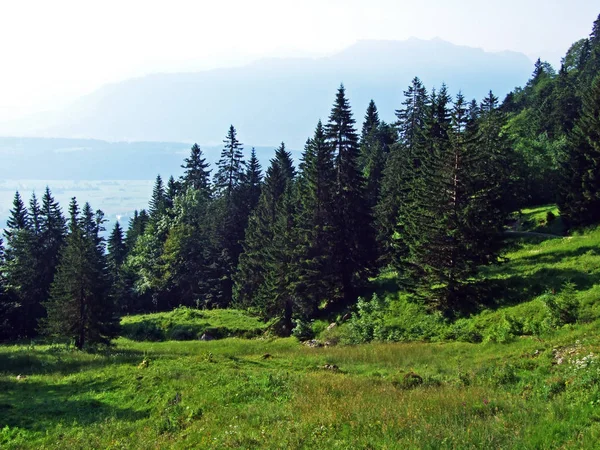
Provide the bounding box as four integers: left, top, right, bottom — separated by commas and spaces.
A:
0, 216, 600, 449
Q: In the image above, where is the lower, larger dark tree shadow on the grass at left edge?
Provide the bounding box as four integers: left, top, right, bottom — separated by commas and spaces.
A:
0, 379, 149, 432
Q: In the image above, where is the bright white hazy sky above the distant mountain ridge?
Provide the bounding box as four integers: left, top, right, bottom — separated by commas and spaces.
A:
0, 0, 600, 120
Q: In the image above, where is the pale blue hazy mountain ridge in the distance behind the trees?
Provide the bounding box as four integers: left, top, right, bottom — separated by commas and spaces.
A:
0, 38, 532, 150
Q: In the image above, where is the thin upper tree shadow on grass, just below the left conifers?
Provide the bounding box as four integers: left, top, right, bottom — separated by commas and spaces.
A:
0, 347, 144, 375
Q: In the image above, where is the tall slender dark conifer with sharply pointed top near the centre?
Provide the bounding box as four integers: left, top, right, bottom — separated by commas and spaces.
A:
325, 85, 375, 307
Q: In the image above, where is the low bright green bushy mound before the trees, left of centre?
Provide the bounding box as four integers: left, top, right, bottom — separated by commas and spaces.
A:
121, 307, 268, 342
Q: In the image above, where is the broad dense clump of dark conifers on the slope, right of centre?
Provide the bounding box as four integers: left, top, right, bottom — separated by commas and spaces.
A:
399, 87, 511, 314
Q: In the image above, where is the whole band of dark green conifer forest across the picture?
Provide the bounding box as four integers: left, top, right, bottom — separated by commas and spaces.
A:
0, 14, 600, 347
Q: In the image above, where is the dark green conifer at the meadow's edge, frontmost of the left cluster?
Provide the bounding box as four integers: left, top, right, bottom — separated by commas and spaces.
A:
42, 199, 118, 349
